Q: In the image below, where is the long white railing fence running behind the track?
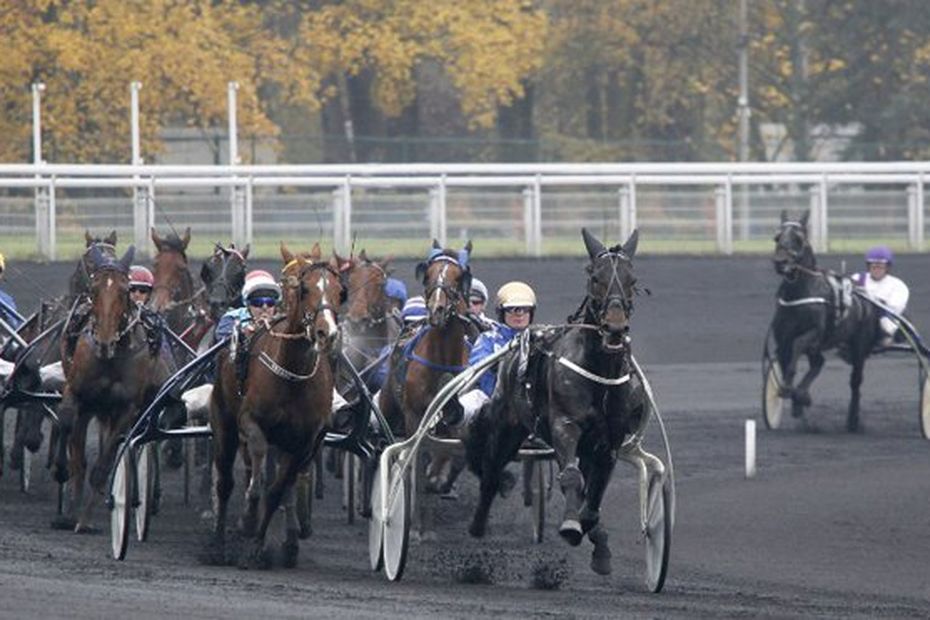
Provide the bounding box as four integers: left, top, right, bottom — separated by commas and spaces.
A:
0, 162, 930, 258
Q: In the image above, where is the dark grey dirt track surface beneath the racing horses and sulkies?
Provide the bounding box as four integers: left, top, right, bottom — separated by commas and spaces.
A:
0, 256, 930, 618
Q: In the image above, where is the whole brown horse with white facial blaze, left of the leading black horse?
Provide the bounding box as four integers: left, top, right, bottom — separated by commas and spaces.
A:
210, 244, 345, 566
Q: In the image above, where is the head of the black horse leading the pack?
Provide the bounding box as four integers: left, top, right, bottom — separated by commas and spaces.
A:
581, 228, 639, 352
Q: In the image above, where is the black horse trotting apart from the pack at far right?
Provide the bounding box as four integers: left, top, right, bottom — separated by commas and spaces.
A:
771, 211, 880, 432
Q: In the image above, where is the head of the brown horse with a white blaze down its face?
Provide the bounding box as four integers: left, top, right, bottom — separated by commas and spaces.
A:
281, 243, 347, 350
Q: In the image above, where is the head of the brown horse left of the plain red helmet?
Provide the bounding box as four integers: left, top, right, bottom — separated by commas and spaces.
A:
90, 246, 136, 359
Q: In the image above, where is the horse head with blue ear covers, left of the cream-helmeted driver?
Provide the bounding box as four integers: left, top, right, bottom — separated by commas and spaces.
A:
416, 239, 472, 328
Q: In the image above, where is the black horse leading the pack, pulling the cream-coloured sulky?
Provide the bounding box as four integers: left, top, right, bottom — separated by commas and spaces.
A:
465, 230, 646, 574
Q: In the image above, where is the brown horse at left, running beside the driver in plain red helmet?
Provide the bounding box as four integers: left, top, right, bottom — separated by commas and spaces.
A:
53, 246, 169, 532
